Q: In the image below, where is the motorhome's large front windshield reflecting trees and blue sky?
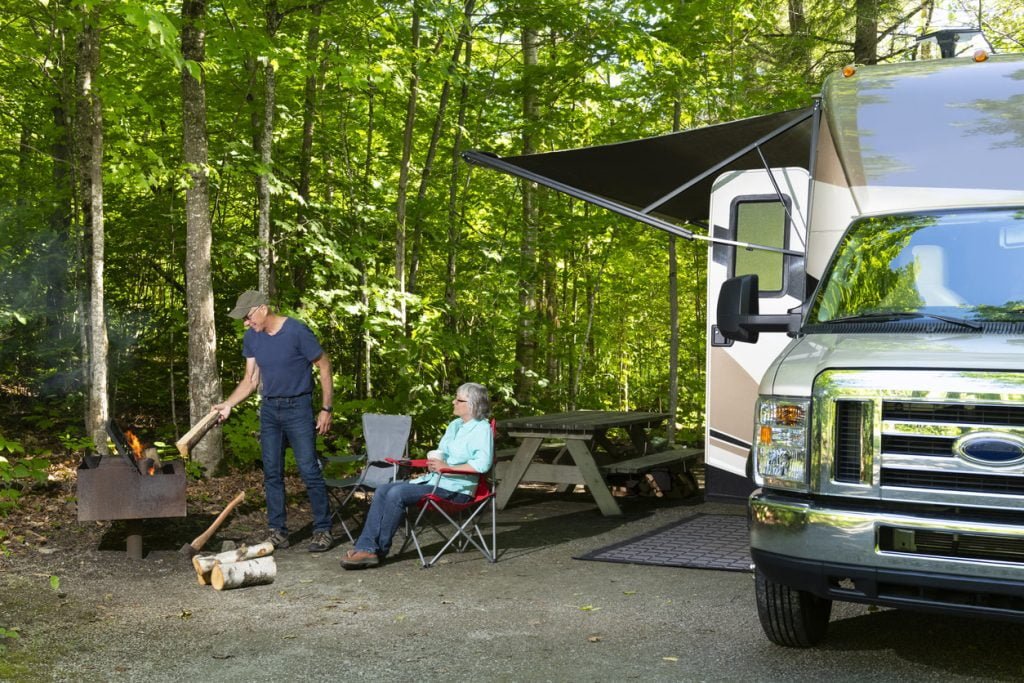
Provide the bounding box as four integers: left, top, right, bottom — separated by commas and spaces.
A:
807, 209, 1024, 327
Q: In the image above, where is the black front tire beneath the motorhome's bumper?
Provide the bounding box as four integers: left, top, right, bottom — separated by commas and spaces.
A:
754, 568, 831, 647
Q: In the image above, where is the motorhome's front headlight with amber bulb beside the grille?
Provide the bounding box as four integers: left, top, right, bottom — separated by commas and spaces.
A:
754, 396, 811, 490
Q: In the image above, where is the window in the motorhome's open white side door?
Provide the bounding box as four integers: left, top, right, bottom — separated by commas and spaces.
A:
733, 198, 786, 295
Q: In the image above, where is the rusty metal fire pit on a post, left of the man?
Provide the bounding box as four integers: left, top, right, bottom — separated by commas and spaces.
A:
78, 423, 185, 559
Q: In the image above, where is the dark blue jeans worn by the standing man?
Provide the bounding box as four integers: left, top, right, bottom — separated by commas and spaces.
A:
259, 393, 331, 533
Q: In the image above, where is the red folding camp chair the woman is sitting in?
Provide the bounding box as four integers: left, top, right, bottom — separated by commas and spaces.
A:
389, 420, 498, 568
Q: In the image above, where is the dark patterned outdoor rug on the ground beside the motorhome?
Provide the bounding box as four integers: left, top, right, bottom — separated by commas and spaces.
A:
575, 514, 751, 571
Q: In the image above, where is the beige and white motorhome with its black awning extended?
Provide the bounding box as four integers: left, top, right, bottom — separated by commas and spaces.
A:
467, 31, 1024, 646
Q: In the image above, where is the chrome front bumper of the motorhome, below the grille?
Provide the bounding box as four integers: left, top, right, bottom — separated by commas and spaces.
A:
750, 490, 1024, 622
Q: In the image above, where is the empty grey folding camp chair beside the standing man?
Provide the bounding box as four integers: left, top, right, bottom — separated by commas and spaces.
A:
324, 413, 413, 543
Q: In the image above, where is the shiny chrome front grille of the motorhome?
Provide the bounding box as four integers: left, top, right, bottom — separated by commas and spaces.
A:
812, 370, 1024, 510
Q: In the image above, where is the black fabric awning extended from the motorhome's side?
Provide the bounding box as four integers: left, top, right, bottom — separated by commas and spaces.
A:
463, 109, 812, 244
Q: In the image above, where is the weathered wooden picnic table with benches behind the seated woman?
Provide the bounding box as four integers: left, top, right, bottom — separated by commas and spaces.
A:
496, 411, 702, 516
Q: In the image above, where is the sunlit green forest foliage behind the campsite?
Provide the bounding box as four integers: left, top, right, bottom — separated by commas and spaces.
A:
0, 0, 1024, 462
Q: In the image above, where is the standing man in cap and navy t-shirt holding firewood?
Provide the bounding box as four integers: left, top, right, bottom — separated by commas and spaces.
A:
213, 290, 334, 553
